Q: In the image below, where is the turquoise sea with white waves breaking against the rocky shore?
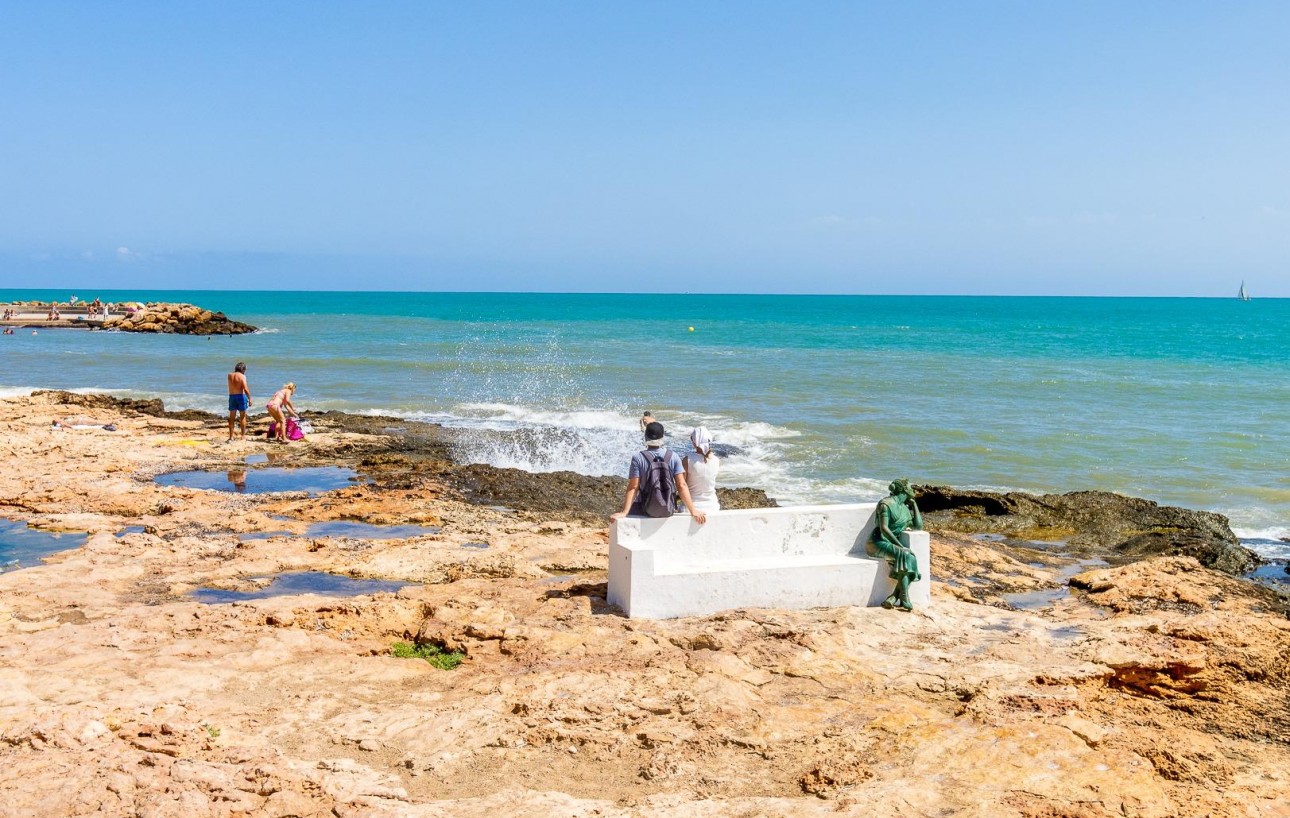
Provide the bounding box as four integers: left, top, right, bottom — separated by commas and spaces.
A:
0, 290, 1290, 556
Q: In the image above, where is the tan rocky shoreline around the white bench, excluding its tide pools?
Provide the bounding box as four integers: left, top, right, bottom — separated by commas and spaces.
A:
0, 392, 1290, 818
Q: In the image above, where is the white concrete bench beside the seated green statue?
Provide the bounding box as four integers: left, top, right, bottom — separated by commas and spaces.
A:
609, 503, 931, 619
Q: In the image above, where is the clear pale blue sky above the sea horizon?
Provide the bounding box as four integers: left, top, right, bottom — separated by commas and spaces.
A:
0, 0, 1290, 297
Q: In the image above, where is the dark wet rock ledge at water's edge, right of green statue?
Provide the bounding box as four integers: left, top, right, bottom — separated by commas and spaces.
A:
916, 485, 1262, 575
